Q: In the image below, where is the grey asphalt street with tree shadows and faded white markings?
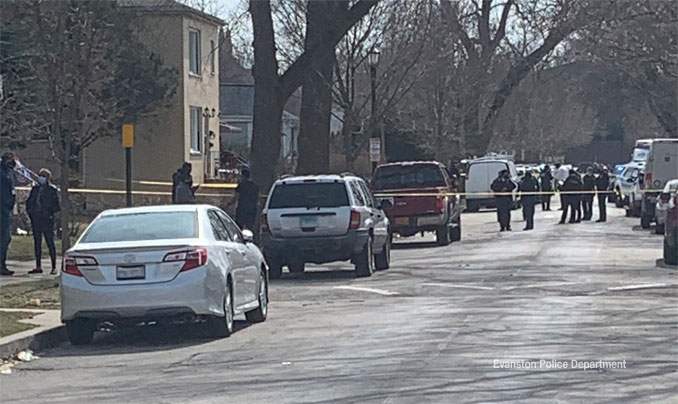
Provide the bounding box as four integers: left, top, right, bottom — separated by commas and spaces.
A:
0, 205, 678, 404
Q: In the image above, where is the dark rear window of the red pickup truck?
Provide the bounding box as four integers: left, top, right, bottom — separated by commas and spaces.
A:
374, 164, 446, 190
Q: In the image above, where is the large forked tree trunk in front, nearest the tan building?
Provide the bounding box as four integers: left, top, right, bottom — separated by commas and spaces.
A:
250, 0, 379, 189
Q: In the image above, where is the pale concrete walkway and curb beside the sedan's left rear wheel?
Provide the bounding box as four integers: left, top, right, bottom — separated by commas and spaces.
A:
0, 309, 66, 359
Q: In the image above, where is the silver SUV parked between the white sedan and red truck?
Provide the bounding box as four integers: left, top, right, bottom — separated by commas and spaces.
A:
261, 175, 391, 278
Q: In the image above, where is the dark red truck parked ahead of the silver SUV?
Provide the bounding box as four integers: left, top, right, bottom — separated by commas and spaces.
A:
370, 161, 461, 245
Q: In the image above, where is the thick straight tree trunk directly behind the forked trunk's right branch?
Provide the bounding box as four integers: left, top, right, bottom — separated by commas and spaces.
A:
297, 0, 348, 174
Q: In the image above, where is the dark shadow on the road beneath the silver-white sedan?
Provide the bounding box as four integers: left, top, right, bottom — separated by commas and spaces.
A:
49, 320, 251, 357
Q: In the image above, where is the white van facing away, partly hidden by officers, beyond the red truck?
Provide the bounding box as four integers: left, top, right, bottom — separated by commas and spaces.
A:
465, 156, 519, 212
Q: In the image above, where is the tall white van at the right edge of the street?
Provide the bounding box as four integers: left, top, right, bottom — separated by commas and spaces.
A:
640, 139, 678, 229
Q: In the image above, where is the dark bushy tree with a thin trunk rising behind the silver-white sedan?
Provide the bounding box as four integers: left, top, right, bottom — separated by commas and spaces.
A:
2, 0, 176, 250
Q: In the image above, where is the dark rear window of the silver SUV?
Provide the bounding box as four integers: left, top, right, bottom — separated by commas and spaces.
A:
268, 182, 349, 209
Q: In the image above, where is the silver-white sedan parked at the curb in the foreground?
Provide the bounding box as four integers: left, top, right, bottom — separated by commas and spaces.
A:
61, 205, 268, 344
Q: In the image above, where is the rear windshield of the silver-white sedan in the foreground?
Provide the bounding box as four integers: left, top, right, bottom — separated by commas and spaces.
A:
81, 212, 198, 243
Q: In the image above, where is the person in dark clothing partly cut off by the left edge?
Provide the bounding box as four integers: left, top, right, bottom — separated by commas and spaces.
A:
0, 152, 16, 275
